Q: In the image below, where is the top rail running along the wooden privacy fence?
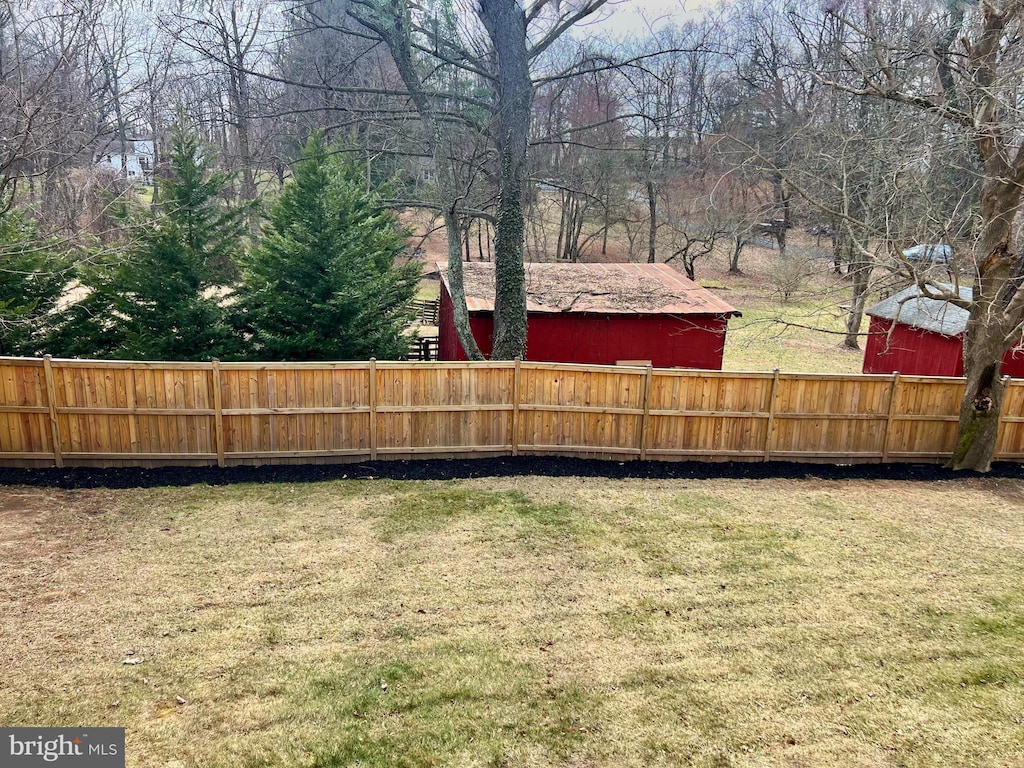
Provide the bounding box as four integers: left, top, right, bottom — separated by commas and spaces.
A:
0, 355, 1024, 387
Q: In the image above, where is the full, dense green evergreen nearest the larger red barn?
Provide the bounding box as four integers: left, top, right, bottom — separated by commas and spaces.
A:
239, 136, 419, 360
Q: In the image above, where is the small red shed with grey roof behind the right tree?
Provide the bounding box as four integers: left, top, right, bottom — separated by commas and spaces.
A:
862, 286, 1024, 378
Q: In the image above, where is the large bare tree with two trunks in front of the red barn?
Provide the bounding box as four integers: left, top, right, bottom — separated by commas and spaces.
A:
335, 0, 604, 358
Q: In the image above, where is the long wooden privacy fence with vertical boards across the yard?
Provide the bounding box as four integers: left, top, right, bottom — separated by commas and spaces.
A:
6, 357, 1024, 467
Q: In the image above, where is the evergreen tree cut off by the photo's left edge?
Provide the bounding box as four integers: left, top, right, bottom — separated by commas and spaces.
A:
0, 210, 69, 355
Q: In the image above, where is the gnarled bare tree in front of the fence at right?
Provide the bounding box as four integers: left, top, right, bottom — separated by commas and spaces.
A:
800, 0, 1024, 471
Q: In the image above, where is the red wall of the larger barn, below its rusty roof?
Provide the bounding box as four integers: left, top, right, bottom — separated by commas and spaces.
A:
438, 284, 727, 371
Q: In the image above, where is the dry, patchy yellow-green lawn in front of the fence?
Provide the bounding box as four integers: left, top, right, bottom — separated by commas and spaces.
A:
0, 478, 1024, 768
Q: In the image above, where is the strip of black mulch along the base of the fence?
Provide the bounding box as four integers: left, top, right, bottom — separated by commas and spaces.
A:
0, 456, 1024, 488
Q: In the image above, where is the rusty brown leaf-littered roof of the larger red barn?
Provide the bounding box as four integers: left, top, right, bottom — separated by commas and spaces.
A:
437, 262, 739, 316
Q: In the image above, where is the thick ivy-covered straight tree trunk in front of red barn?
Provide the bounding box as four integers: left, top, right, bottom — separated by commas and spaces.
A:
479, 0, 534, 359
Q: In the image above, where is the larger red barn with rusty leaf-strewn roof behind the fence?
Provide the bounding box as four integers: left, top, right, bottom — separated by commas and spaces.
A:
438, 262, 739, 370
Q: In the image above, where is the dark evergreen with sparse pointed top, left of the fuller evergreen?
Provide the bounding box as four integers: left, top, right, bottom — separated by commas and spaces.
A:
53, 130, 245, 360
